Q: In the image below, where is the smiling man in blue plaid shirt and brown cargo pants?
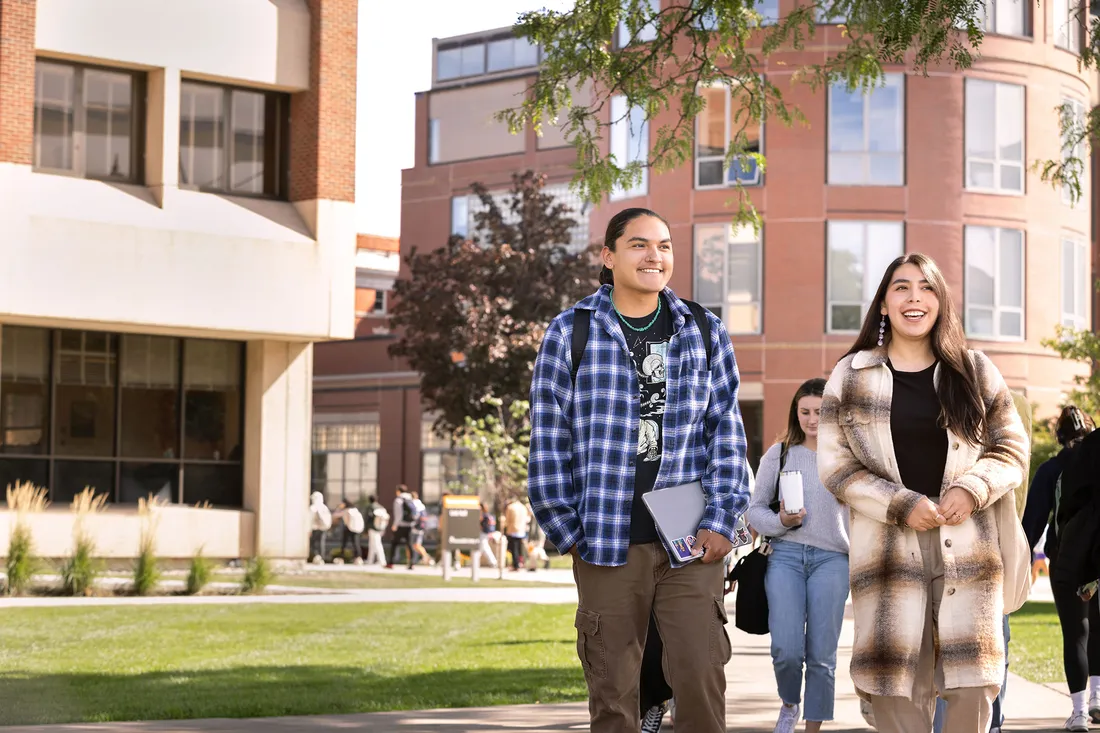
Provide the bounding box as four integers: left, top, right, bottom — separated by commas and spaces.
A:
528, 209, 749, 733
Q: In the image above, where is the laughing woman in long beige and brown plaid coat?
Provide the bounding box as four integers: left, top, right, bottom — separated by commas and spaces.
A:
817, 253, 1030, 733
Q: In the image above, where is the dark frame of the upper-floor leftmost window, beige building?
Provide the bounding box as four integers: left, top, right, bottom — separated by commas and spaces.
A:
31, 56, 147, 186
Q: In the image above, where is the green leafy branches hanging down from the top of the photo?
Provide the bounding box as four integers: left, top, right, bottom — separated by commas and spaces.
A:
497, 0, 1100, 216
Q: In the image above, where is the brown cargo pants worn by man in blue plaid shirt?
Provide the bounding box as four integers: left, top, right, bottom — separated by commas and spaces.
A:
573, 543, 732, 733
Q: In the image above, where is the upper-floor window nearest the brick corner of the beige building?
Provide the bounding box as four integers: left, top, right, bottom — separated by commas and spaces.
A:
179, 81, 289, 198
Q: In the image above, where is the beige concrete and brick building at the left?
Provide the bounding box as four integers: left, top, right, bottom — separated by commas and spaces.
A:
0, 0, 382, 558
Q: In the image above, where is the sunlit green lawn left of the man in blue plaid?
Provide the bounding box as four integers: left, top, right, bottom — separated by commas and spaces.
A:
0, 603, 585, 725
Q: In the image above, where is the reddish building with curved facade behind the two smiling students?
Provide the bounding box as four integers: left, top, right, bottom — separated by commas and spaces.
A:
316, 0, 1097, 517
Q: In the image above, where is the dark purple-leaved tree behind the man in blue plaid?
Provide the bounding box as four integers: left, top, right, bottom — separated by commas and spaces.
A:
389, 171, 595, 434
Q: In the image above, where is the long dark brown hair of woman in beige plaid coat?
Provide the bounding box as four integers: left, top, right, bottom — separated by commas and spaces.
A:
845, 252, 986, 446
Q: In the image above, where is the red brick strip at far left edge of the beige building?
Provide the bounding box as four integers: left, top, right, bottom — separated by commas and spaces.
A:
0, 0, 35, 165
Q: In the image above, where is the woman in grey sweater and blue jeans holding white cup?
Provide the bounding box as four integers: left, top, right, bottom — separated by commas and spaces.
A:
747, 379, 848, 733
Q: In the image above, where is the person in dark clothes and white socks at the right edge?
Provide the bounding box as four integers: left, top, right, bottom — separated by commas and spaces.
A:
1024, 405, 1100, 732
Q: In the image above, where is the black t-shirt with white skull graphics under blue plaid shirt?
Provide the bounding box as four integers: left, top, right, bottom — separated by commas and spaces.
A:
619, 295, 672, 545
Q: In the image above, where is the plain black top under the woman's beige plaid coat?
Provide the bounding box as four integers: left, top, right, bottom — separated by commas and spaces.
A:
887, 362, 947, 501
